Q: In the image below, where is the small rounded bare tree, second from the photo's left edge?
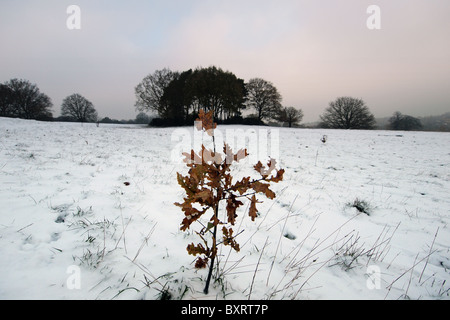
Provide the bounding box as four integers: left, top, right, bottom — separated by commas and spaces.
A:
61, 93, 97, 122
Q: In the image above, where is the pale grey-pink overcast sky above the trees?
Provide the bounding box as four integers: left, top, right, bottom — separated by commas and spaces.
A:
0, 0, 450, 122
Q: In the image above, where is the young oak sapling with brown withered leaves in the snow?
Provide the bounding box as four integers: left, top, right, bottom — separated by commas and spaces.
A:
175, 110, 284, 294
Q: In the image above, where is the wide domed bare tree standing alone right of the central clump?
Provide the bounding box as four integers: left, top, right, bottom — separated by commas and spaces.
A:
320, 97, 375, 129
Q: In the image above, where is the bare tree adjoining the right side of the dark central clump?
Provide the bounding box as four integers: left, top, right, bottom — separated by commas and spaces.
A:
246, 78, 282, 122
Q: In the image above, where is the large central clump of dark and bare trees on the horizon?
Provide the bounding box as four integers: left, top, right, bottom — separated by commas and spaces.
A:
135, 66, 303, 126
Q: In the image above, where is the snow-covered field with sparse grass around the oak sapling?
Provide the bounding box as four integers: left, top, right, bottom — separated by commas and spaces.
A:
0, 118, 450, 300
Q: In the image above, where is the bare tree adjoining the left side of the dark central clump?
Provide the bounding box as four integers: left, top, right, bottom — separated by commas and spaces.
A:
134, 68, 179, 116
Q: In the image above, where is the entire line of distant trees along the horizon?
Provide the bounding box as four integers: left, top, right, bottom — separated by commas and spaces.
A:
0, 76, 450, 131
